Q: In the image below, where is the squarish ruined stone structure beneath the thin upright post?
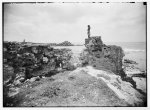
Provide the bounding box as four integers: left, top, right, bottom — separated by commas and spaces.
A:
85, 26, 125, 76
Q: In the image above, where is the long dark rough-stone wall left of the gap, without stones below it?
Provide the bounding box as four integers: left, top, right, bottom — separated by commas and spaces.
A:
3, 42, 72, 82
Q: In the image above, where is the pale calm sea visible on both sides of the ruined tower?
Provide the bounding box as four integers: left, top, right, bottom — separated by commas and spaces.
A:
54, 42, 147, 71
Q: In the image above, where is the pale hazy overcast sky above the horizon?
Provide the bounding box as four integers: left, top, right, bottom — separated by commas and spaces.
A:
4, 3, 146, 43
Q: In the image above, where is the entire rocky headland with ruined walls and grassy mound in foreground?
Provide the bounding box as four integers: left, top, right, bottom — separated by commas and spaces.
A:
3, 36, 147, 107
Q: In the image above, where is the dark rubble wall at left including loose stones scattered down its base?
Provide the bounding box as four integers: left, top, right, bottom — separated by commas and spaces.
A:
3, 42, 74, 106
